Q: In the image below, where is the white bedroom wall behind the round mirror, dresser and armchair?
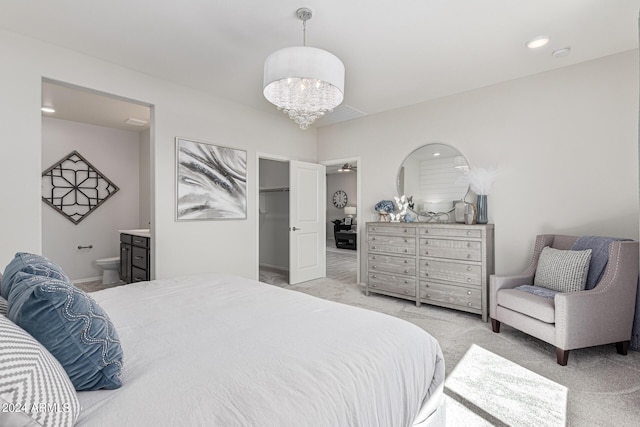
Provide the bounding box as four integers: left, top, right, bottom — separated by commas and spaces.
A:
318, 50, 638, 277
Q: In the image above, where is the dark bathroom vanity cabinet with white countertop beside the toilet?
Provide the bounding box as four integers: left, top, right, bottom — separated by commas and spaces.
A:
118, 229, 151, 283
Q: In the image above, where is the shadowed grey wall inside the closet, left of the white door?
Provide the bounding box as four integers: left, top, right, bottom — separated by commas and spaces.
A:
259, 159, 289, 271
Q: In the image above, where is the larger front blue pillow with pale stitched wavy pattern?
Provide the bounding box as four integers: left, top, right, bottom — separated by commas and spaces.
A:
2, 265, 123, 391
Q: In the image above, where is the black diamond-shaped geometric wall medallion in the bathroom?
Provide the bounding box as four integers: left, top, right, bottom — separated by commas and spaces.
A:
42, 151, 119, 224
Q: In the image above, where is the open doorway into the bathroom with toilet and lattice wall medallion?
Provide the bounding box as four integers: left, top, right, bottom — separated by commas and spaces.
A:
41, 78, 155, 291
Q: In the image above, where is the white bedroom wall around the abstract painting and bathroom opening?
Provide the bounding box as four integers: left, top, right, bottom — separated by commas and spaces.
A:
0, 30, 317, 284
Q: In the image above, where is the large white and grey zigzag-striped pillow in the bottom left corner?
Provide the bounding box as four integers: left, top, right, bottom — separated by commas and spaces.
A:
0, 316, 80, 427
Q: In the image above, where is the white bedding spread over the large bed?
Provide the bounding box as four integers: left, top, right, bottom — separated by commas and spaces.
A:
77, 274, 444, 427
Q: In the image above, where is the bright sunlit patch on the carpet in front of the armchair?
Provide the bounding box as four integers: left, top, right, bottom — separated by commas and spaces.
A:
445, 344, 568, 427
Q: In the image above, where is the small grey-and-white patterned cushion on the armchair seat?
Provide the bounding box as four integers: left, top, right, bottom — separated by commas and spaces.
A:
533, 246, 591, 292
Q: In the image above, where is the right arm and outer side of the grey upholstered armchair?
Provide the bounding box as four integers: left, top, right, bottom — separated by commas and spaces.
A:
555, 242, 638, 350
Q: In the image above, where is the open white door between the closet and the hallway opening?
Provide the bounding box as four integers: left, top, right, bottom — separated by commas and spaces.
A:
289, 160, 327, 284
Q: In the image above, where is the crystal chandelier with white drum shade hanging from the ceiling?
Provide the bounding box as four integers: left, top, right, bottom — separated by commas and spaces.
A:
263, 8, 344, 129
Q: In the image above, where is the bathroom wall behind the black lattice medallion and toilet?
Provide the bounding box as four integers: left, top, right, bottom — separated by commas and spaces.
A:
41, 118, 140, 280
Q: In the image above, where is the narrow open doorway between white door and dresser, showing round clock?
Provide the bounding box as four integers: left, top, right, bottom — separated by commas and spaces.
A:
325, 157, 361, 283
